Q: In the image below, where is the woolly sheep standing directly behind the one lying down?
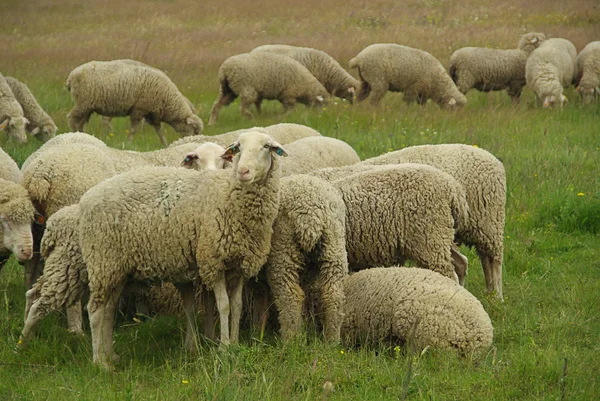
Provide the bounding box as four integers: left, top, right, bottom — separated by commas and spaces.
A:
311, 163, 469, 281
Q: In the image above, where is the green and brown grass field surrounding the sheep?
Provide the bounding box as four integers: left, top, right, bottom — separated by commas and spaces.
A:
0, 0, 600, 401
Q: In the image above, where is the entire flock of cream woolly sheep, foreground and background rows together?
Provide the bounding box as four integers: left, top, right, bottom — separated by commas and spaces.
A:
0, 33, 600, 368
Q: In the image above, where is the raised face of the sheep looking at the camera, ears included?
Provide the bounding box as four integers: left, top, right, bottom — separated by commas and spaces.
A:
221, 131, 287, 185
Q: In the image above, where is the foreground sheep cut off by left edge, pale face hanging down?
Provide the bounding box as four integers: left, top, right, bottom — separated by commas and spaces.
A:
0, 148, 35, 270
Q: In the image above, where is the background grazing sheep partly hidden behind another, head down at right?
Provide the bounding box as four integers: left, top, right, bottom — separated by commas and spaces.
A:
252, 45, 360, 103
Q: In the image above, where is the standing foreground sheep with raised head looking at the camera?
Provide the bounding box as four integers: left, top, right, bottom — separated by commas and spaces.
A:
79, 132, 286, 368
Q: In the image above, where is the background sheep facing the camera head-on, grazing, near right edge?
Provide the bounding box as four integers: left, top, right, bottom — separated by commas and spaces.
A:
525, 38, 577, 107
